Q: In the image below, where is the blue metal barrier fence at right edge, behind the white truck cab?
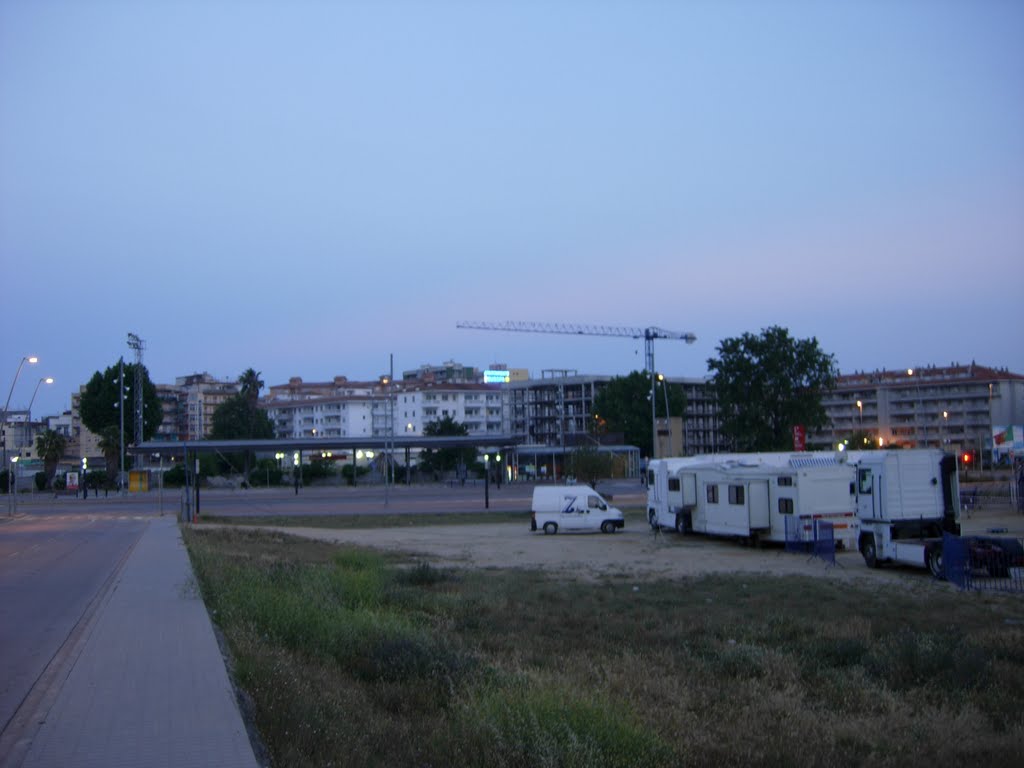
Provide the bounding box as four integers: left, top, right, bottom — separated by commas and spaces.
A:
942, 534, 1024, 593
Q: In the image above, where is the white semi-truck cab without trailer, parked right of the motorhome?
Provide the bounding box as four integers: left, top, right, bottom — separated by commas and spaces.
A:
847, 449, 961, 579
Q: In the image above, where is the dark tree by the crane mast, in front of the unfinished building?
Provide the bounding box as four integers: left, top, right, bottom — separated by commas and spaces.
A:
593, 371, 686, 455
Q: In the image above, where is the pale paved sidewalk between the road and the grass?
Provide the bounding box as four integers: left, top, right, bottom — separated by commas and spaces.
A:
13, 517, 257, 768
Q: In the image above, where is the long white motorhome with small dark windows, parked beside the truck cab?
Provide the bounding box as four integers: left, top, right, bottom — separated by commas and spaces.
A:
647, 453, 858, 549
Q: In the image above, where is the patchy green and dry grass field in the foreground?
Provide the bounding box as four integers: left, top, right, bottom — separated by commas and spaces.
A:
184, 528, 1024, 767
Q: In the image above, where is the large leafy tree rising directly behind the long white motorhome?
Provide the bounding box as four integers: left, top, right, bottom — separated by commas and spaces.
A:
708, 326, 839, 451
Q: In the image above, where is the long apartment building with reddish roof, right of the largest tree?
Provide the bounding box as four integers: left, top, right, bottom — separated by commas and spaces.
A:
808, 362, 1024, 458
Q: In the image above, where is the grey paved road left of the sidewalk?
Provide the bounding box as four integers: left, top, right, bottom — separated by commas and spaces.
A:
0, 505, 152, 731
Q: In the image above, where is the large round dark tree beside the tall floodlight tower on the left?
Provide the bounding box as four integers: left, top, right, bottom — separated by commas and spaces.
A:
79, 362, 164, 445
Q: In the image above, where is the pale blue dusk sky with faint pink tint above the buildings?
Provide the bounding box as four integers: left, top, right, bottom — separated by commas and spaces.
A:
0, 0, 1024, 417
